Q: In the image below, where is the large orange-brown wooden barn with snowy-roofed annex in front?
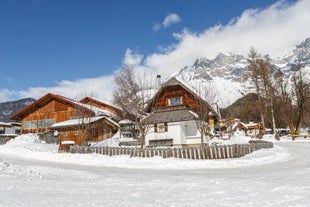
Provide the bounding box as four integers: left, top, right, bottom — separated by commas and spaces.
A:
11, 93, 118, 144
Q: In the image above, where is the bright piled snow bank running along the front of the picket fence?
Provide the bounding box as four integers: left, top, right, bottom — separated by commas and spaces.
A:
0, 134, 291, 170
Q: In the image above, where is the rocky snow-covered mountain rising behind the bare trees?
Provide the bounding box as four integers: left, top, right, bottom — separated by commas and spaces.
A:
176, 38, 310, 107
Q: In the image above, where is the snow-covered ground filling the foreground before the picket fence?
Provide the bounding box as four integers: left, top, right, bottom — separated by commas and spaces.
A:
0, 136, 310, 207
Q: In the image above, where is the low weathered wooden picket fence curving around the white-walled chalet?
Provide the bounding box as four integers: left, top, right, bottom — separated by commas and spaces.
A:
69, 140, 273, 159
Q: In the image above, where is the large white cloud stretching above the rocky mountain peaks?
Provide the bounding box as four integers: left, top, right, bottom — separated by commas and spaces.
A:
143, 0, 310, 80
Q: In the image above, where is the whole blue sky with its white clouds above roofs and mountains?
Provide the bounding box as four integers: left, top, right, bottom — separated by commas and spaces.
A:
0, 0, 310, 102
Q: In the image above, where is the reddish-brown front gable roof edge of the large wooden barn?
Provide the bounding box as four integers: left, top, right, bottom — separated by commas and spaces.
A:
10, 93, 91, 120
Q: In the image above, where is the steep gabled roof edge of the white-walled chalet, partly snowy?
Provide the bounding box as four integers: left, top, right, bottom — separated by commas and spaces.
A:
146, 76, 218, 115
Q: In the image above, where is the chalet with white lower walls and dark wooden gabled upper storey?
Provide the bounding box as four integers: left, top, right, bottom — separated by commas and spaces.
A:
144, 77, 217, 146
